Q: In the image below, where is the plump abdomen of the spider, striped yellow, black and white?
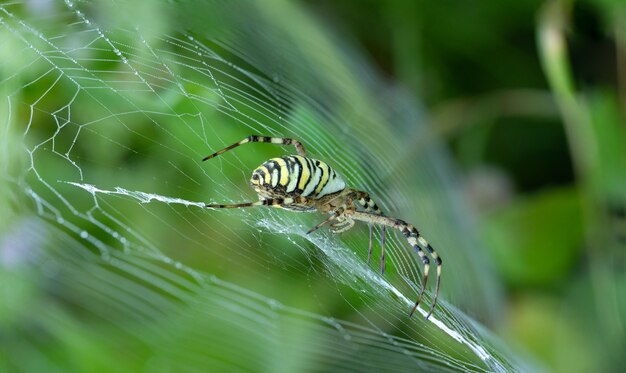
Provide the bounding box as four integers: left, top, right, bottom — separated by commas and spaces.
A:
250, 155, 346, 199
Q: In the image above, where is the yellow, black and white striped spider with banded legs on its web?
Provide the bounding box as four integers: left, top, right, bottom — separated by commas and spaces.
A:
202, 135, 441, 319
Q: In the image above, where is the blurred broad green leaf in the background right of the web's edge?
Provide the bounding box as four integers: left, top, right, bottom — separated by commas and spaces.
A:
483, 188, 584, 288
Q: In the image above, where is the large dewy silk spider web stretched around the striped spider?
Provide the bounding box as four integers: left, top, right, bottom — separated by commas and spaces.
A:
0, 1, 527, 371
